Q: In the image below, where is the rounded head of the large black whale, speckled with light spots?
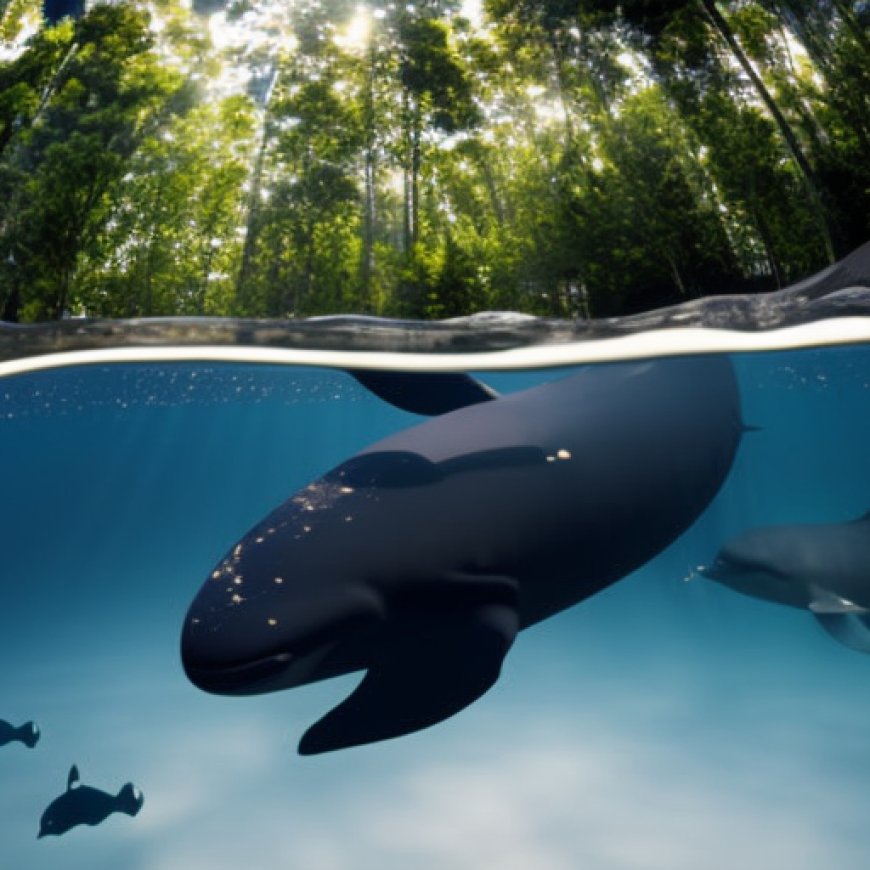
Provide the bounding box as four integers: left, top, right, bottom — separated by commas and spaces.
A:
181, 473, 380, 695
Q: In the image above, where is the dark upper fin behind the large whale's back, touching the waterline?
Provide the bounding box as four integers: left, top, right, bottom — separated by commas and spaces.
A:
347, 369, 498, 417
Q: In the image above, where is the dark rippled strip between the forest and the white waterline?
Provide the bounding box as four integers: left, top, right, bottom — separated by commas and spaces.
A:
0, 242, 870, 360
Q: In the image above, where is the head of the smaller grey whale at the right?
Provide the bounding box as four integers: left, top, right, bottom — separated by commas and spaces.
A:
700, 529, 812, 607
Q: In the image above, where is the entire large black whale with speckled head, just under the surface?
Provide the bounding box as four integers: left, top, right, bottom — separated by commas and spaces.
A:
181, 356, 742, 754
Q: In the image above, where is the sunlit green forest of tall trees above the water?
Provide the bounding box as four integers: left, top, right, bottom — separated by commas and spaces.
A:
0, 0, 870, 323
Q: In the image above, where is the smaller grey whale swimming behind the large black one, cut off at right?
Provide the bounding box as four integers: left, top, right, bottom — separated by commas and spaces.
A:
700, 513, 870, 653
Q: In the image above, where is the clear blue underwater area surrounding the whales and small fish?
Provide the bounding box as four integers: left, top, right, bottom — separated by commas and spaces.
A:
0, 346, 870, 870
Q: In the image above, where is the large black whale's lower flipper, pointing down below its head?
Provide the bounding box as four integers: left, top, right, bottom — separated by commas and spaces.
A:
299, 578, 519, 755
